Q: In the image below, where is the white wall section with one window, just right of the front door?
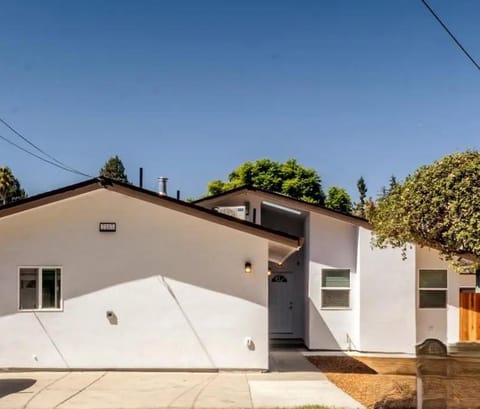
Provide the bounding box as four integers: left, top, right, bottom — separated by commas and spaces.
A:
305, 213, 358, 350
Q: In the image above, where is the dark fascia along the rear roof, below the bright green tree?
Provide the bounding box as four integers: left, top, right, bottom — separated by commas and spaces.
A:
193, 186, 372, 229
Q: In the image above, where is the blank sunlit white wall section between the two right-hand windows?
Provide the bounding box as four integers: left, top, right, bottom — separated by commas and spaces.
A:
358, 227, 415, 353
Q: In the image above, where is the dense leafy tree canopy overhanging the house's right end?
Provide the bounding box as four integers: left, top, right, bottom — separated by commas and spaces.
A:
367, 151, 480, 263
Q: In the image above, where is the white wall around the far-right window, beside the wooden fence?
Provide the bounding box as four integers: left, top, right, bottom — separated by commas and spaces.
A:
416, 247, 475, 344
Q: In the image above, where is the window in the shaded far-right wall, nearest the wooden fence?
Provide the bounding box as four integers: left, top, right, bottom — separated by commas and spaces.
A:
418, 270, 448, 308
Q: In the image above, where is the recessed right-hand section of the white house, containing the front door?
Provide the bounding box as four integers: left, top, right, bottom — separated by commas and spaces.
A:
196, 188, 480, 353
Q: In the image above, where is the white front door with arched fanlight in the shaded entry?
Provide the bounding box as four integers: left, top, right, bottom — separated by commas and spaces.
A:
268, 273, 293, 334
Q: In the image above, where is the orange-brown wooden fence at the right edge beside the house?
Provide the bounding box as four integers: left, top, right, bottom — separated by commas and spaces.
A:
460, 289, 480, 342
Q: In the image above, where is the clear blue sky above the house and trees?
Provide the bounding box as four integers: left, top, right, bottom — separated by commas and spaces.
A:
0, 0, 480, 199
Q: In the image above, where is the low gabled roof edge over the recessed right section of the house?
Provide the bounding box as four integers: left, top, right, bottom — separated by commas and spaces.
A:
193, 186, 372, 229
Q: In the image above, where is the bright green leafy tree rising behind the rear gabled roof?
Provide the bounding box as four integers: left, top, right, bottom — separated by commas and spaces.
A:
207, 159, 325, 204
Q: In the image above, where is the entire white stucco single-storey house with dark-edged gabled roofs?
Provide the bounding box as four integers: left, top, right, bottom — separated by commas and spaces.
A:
0, 179, 480, 370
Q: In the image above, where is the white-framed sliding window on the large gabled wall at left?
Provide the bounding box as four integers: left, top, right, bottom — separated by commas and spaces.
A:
18, 266, 62, 311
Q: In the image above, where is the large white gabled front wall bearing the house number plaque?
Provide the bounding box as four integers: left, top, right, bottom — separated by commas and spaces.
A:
0, 189, 268, 369
